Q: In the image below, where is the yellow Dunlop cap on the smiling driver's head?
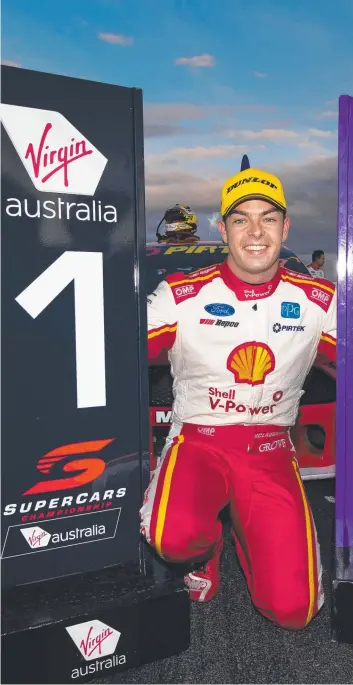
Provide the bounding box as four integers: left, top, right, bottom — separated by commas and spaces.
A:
221, 169, 287, 216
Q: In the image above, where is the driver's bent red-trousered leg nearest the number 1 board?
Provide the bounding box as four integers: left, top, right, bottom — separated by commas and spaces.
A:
140, 427, 228, 562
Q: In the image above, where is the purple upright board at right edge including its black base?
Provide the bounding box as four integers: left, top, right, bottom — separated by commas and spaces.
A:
332, 95, 353, 644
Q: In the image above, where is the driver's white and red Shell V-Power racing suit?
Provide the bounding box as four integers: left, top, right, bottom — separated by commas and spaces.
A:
140, 262, 336, 629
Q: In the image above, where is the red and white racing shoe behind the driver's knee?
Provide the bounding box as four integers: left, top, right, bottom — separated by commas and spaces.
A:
184, 537, 223, 602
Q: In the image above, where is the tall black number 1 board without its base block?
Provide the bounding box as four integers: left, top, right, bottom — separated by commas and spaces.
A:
1, 67, 148, 587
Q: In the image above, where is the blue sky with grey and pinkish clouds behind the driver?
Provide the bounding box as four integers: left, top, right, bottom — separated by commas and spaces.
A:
2, 0, 353, 278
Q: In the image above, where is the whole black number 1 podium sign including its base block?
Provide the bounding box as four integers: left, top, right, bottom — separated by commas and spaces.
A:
1, 67, 190, 684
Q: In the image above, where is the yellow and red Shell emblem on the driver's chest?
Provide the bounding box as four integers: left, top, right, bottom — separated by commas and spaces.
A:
227, 341, 275, 385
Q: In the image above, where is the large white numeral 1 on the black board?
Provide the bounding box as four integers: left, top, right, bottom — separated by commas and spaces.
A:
15, 251, 106, 409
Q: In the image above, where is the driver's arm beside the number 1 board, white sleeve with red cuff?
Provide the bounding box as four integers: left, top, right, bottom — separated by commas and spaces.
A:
147, 281, 178, 359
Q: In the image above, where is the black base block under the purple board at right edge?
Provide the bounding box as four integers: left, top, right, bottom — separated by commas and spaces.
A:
332, 580, 353, 645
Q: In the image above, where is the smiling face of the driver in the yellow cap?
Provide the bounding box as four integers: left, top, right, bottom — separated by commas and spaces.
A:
218, 200, 290, 274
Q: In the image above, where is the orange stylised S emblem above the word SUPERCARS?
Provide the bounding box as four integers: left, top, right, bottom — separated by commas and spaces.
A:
22, 438, 115, 495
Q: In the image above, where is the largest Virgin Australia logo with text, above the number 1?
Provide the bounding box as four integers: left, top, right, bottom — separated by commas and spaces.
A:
1, 104, 117, 223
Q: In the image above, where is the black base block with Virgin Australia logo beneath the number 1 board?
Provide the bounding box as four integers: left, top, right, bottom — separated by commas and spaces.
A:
1, 567, 190, 685
